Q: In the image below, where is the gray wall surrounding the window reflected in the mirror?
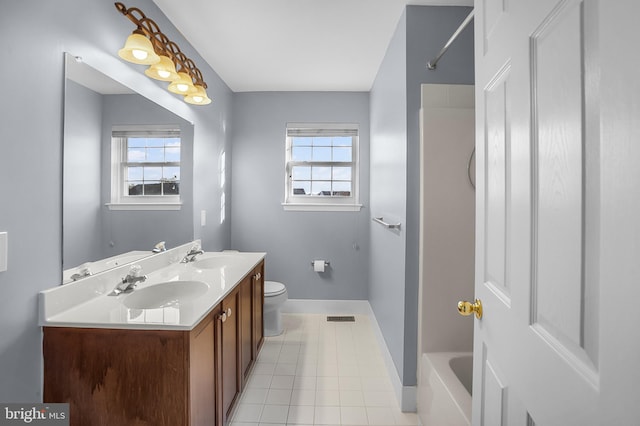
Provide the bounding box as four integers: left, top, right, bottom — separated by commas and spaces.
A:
99, 95, 194, 258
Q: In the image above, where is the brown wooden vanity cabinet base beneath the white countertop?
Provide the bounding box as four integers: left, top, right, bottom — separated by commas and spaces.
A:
43, 262, 264, 426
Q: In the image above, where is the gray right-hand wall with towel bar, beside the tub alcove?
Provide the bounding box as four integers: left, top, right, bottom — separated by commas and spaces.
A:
369, 6, 474, 386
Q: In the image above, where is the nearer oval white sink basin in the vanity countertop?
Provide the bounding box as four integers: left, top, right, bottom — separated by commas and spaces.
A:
122, 281, 209, 309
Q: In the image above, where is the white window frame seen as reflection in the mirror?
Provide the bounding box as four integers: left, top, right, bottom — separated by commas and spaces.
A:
106, 124, 182, 210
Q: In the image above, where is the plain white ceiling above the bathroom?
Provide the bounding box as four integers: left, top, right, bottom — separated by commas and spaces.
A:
151, 0, 473, 92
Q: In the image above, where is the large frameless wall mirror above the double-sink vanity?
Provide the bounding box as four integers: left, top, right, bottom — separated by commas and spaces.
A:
62, 53, 193, 282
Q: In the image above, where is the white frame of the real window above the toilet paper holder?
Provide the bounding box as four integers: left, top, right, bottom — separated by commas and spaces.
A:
282, 123, 362, 211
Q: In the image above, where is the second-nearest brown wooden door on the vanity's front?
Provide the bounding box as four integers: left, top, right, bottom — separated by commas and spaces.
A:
220, 287, 240, 424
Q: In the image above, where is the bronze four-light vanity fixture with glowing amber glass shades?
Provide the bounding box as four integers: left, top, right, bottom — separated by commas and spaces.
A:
115, 2, 211, 105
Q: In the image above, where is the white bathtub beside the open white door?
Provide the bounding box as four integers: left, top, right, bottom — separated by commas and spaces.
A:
417, 352, 473, 426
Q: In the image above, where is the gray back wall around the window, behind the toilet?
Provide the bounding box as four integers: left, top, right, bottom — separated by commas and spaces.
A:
231, 92, 370, 300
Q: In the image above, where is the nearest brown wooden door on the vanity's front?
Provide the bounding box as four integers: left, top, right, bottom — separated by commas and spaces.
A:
189, 315, 216, 426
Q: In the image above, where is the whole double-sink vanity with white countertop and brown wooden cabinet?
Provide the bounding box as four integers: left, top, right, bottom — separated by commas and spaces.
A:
39, 243, 265, 426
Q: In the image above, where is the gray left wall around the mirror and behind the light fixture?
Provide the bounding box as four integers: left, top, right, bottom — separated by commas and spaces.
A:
0, 0, 232, 402
